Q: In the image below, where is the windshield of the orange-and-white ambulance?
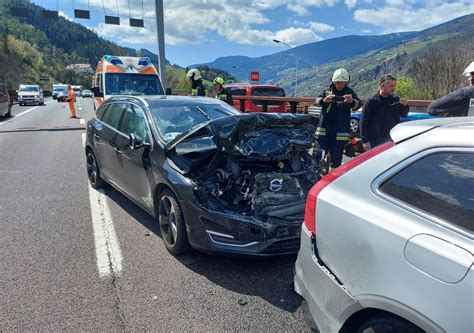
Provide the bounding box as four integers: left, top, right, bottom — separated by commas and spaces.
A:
105, 73, 163, 95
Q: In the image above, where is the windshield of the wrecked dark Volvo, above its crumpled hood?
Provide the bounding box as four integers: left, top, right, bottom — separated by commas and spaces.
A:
151, 104, 240, 143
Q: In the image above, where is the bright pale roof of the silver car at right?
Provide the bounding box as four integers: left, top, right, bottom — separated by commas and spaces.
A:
390, 117, 474, 143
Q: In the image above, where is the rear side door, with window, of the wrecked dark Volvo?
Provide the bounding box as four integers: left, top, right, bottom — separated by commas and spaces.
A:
92, 103, 125, 184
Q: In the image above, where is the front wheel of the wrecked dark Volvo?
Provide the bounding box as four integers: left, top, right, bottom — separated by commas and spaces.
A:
158, 189, 190, 255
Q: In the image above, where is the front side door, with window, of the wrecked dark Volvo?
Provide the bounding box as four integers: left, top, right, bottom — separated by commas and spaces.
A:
116, 103, 153, 209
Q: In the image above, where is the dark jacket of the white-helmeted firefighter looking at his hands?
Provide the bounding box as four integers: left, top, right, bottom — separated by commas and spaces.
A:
316, 84, 361, 143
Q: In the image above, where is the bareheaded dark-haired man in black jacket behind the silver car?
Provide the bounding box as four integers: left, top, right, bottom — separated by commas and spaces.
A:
360, 74, 410, 150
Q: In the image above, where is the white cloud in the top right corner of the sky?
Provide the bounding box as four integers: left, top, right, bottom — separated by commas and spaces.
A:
354, 0, 474, 33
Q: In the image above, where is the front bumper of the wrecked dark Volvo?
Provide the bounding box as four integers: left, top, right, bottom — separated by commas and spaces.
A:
180, 201, 303, 256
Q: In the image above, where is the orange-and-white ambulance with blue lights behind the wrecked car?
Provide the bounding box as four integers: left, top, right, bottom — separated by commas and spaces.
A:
92, 55, 164, 108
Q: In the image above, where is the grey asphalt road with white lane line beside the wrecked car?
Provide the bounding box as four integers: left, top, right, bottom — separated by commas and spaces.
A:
0, 98, 308, 332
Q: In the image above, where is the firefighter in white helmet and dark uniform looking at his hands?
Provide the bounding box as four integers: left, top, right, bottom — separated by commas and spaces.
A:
316, 68, 361, 171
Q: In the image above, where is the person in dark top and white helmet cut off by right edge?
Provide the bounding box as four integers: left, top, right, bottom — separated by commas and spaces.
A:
428, 62, 474, 117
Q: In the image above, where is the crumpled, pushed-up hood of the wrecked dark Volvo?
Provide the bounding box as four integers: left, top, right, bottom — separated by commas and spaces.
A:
165, 113, 319, 157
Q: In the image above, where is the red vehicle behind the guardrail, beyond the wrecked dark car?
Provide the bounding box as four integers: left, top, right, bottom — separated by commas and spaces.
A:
224, 83, 288, 112
